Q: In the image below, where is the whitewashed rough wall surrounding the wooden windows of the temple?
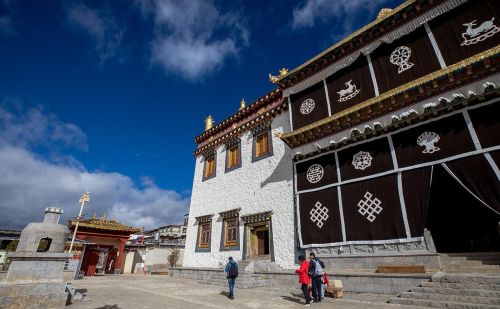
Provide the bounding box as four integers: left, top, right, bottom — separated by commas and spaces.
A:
183, 111, 297, 269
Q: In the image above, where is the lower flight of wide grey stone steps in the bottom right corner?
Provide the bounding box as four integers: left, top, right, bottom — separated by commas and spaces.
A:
389, 272, 500, 309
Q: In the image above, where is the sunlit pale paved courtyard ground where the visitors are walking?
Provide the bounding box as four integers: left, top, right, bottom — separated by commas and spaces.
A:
67, 275, 428, 309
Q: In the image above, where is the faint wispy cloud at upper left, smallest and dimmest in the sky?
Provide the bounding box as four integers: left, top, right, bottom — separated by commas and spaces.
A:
66, 3, 125, 62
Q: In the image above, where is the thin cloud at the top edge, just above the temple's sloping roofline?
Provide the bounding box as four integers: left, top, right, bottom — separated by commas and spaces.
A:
292, 0, 387, 37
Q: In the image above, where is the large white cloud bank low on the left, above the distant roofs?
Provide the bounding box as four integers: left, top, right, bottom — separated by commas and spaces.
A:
0, 100, 189, 228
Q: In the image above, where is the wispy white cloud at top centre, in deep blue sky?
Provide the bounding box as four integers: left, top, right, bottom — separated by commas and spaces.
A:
139, 0, 249, 80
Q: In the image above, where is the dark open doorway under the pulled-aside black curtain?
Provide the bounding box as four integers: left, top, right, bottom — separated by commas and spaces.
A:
426, 165, 500, 253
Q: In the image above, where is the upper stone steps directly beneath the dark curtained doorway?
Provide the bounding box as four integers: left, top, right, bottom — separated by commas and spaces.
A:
439, 252, 500, 274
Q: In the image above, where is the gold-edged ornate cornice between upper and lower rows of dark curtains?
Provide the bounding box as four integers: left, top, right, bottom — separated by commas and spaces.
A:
281, 46, 500, 147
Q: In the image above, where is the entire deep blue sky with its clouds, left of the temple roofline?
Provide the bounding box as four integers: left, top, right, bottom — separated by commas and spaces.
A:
0, 0, 402, 229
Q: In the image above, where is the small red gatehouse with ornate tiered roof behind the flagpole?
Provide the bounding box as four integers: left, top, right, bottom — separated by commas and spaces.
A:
68, 214, 141, 276
